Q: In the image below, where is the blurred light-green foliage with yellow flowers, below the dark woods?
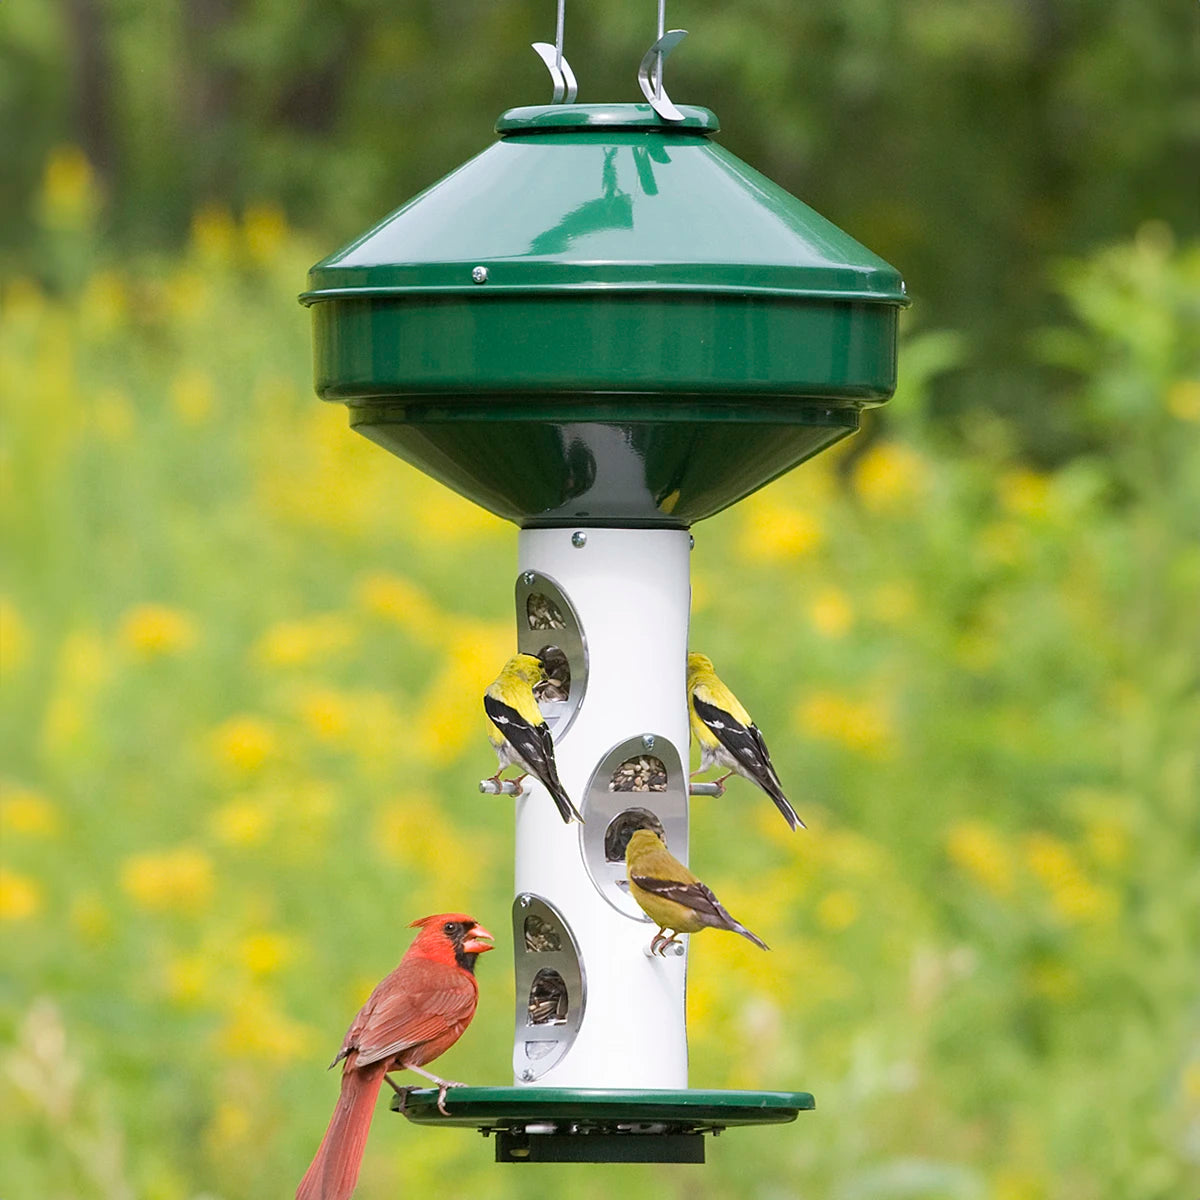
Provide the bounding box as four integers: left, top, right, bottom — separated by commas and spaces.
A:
0, 175, 1200, 1200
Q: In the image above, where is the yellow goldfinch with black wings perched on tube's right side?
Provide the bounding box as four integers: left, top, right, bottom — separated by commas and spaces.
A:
688, 654, 804, 829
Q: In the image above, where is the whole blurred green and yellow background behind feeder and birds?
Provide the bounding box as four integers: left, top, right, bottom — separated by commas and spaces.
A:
0, 0, 1200, 1200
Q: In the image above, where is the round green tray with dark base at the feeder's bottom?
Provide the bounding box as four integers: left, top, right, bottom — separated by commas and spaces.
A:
391, 1087, 816, 1163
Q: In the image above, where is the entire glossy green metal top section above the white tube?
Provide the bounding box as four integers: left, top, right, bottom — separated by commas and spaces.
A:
301, 104, 907, 528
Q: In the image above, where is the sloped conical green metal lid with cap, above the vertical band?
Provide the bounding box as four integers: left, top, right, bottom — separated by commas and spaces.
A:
301, 104, 906, 305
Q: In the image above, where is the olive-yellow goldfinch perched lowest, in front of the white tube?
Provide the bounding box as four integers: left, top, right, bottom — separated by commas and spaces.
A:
625, 829, 769, 954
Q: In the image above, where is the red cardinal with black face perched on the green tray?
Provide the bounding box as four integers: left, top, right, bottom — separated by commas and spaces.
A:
296, 912, 494, 1200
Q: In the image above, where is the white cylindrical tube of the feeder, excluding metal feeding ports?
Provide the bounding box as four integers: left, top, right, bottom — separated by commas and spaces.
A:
516, 528, 690, 1088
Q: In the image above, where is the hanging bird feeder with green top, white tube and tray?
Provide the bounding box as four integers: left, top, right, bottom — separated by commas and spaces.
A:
301, 9, 907, 1162
